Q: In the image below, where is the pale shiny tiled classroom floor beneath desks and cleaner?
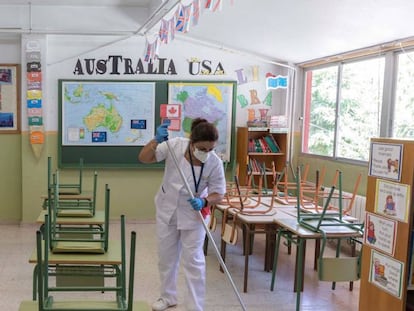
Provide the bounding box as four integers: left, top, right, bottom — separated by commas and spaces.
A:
0, 223, 359, 311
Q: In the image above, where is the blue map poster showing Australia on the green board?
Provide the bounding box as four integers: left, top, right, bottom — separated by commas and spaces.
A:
61, 81, 155, 146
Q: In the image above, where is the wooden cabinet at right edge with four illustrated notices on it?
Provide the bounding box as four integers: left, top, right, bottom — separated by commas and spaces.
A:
359, 138, 414, 311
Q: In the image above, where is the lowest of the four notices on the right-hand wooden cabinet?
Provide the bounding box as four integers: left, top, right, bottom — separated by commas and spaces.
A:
369, 250, 404, 299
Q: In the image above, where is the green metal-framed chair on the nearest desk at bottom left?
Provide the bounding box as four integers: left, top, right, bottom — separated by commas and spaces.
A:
29, 216, 140, 311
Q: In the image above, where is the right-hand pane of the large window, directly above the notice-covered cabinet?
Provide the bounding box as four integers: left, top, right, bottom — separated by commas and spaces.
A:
336, 57, 385, 161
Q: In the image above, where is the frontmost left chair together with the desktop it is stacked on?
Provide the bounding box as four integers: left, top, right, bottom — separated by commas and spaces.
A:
19, 215, 150, 311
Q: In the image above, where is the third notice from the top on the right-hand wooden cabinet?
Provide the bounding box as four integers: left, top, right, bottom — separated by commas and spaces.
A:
364, 213, 398, 256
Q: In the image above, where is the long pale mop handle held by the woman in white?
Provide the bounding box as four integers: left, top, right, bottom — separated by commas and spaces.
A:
166, 140, 247, 311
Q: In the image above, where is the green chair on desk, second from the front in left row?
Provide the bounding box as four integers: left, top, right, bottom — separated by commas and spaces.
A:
45, 177, 110, 253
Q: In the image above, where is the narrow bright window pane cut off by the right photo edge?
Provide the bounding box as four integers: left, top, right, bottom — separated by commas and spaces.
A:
392, 52, 414, 139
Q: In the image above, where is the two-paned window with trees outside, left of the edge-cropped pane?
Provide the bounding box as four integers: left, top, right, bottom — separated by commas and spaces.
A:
302, 57, 385, 161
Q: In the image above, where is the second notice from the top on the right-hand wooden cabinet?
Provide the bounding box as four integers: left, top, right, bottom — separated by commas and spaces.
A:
375, 179, 411, 222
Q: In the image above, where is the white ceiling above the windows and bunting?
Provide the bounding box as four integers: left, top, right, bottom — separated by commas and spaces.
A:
0, 0, 414, 63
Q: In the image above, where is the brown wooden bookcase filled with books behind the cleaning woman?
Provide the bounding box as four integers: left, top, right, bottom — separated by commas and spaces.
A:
236, 127, 288, 188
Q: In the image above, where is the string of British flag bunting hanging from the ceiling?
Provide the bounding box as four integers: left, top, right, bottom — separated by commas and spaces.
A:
144, 0, 234, 62
